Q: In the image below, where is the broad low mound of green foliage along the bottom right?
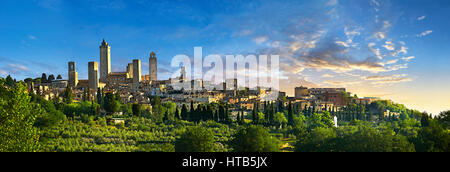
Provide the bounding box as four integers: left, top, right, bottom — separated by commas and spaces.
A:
295, 122, 414, 152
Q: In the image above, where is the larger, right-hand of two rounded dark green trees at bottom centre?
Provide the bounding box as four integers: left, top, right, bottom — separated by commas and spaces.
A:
231, 125, 279, 152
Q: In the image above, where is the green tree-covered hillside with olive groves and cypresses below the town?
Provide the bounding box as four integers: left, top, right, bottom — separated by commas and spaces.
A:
0, 76, 450, 152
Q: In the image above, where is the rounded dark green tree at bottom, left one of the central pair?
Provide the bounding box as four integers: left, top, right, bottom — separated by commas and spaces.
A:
175, 126, 216, 152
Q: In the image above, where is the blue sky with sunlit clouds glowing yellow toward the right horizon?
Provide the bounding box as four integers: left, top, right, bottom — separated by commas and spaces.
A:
0, 0, 450, 114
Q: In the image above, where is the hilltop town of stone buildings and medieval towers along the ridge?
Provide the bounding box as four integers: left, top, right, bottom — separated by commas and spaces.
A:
22, 40, 399, 119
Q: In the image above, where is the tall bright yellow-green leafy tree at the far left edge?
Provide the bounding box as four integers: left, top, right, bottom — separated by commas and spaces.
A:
0, 79, 42, 152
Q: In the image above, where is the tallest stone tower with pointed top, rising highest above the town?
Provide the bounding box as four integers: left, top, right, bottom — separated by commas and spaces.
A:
100, 39, 111, 83
